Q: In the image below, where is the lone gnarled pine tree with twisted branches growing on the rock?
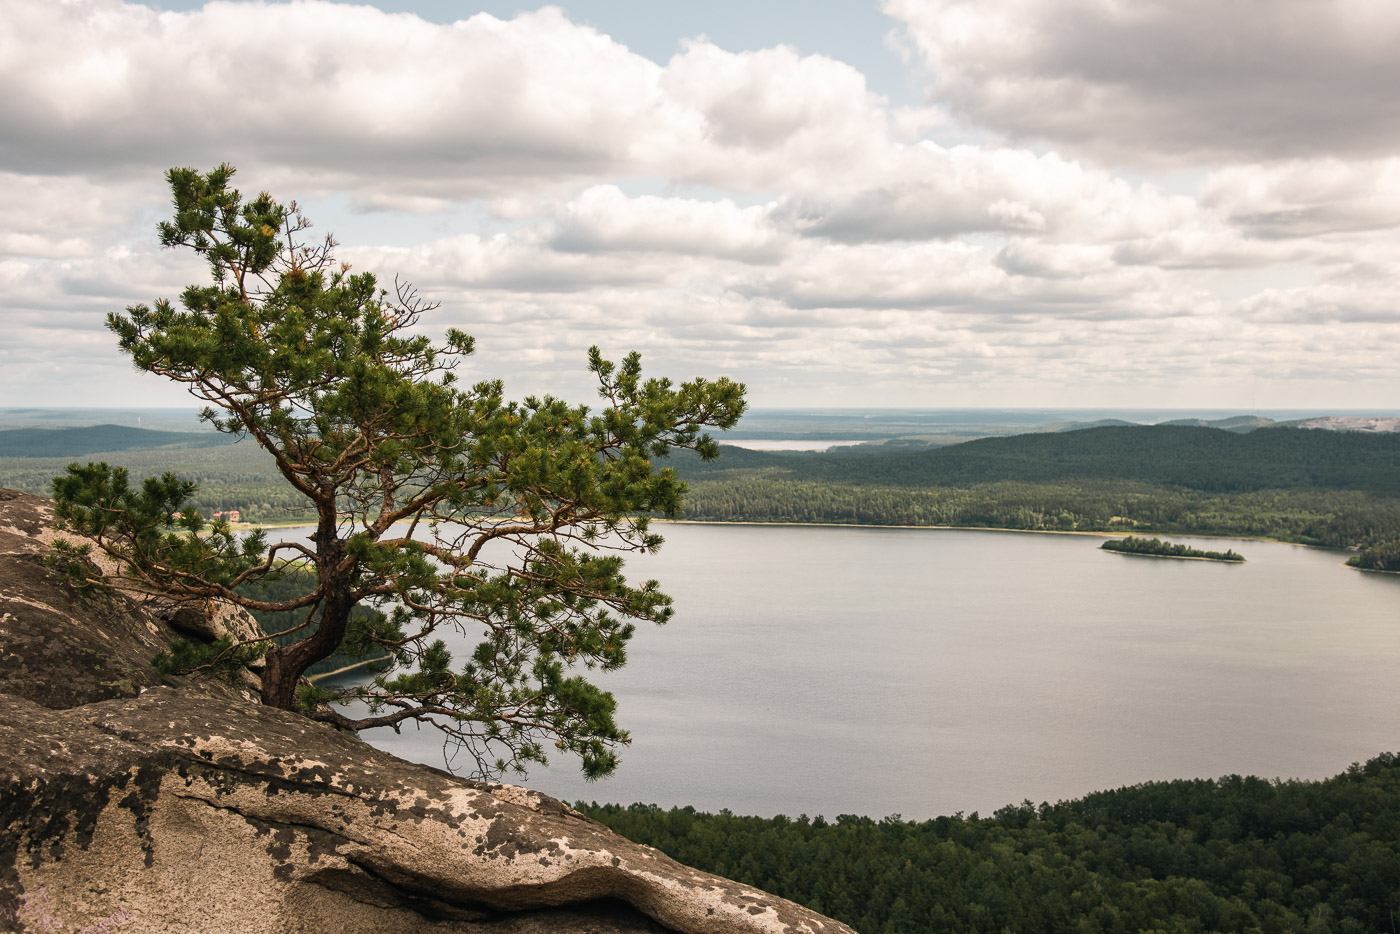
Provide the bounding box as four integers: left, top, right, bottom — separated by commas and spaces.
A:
53, 165, 745, 777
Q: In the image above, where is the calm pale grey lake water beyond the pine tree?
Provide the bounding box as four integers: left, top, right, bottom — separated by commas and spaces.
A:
320, 525, 1400, 819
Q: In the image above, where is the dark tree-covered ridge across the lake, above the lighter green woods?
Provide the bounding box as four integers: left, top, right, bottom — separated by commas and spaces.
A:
676, 424, 1400, 496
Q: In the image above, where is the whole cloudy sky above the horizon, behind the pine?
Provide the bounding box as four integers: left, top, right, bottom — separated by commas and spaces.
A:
0, 0, 1400, 412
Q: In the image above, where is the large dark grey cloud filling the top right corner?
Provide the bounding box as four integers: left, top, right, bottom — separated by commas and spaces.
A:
885, 0, 1400, 167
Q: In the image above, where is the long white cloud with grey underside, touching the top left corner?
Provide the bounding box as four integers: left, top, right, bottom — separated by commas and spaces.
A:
0, 0, 688, 196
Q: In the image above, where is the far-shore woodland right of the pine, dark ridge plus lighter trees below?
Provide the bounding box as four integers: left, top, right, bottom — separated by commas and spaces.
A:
676, 426, 1400, 546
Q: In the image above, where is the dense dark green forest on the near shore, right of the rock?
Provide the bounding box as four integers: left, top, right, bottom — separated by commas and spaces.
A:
577, 753, 1400, 934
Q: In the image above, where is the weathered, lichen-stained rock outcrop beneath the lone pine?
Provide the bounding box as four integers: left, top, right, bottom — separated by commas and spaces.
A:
0, 490, 848, 934
